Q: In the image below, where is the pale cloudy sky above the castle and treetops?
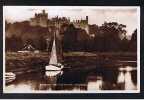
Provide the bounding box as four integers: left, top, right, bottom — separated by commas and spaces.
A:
3, 6, 139, 35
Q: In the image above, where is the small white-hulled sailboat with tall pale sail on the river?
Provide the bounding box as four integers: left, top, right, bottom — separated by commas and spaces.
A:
45, 33, 64, 71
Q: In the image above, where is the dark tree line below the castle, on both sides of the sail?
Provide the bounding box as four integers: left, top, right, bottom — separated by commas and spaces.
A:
5, 22, 137, 52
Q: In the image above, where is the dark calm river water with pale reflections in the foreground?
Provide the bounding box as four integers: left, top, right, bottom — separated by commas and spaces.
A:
5, 66, 137, 93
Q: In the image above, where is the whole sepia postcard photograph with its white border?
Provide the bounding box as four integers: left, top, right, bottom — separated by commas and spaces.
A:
3, 6, 140, 93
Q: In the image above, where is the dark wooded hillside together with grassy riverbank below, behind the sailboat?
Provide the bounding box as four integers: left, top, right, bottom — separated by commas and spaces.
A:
5, 20, 137, 74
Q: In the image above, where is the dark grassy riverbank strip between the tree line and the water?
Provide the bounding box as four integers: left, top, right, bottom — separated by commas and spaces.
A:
5, 52, 137, 74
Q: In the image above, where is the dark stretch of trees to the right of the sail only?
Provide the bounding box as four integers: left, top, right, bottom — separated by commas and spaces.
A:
63, 22, 137, 52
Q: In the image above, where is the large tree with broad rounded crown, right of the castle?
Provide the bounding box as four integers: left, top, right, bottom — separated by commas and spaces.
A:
95, 22, 126, 51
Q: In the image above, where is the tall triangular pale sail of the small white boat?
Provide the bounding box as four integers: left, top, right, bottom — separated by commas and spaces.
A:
49, 33, 58, 65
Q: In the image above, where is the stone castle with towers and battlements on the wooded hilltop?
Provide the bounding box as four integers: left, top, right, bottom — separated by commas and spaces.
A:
30, 10, 89, 33
